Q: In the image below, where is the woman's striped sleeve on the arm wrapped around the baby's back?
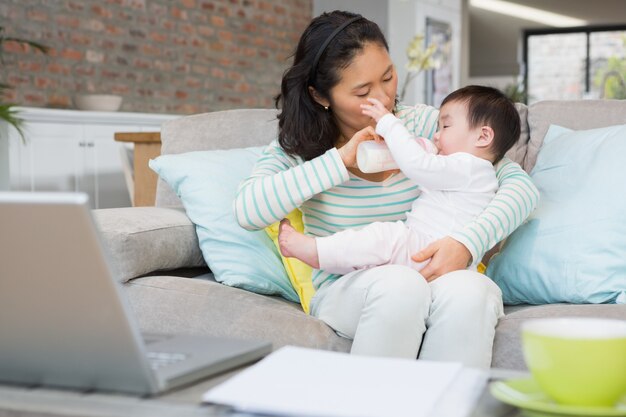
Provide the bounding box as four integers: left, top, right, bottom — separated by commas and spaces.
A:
451, 158, 539, 260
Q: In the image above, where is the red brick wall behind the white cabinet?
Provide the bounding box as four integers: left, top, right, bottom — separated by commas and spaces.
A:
0, 0, 312, 114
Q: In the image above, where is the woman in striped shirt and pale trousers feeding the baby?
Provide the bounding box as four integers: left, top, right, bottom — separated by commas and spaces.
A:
235, 11, 538, 368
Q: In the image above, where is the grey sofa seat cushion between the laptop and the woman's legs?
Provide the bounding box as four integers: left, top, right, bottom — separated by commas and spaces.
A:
126, 274, 352, 352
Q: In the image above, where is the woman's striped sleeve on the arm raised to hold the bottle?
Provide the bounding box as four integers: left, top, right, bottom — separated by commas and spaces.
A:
234, 142, 349, 230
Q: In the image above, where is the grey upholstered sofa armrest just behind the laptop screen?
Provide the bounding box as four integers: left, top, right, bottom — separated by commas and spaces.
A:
93, 207, 206, 282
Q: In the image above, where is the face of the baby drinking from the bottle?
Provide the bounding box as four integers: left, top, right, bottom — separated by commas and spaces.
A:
433, 101, 480, 155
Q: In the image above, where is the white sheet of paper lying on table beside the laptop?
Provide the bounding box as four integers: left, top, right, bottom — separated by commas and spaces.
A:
203, 347, 473, 417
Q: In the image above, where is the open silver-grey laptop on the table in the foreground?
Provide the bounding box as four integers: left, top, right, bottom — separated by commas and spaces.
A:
0, 192, 271, 395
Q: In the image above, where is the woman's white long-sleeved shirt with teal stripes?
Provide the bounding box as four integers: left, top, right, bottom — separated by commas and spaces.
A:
235, 104, 539, 288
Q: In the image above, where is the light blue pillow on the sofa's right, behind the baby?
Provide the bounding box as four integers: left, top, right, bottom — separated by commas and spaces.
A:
487, 125, 626, 304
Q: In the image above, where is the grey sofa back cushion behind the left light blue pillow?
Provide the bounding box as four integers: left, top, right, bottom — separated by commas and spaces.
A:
155, 109, 278, 207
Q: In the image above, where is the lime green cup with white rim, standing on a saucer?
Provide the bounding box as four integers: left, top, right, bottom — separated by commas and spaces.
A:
522, 318, 626, 407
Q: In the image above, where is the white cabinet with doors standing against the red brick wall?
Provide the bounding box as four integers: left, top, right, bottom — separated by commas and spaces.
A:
0, 108, 180, 208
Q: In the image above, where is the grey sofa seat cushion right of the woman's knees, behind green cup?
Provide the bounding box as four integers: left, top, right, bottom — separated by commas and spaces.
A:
491, 304, 626, 370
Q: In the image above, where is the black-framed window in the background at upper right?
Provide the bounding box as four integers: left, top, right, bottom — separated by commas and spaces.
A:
524, 26, 626, 103
